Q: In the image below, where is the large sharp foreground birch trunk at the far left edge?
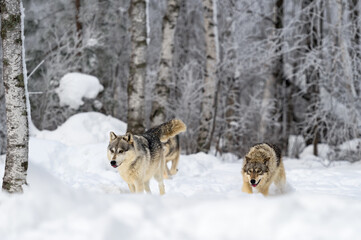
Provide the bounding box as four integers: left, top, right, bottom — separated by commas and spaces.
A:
1, 0, 29, 193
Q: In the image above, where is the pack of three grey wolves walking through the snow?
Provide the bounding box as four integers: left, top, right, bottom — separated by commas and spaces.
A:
107, 119, 286, 196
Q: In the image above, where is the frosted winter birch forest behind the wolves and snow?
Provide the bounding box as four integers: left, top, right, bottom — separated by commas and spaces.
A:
0, 0, 361, 161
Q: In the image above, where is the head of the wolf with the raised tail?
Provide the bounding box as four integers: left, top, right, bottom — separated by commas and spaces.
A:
107, 132, 134, 168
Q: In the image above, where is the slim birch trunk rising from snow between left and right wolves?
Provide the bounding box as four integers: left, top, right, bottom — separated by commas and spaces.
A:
197, 0, 217, 152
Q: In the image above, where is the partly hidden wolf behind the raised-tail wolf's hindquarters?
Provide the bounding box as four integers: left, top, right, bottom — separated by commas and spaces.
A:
163, 135, 180, 178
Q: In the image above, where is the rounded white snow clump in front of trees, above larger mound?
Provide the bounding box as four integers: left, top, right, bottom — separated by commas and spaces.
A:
56, 72, 104, 109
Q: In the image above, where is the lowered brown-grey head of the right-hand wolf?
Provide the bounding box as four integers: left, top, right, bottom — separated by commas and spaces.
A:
243, 156, 269, 187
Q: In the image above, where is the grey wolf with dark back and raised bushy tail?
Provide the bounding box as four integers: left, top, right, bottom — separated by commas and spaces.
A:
107, 119, 186, 195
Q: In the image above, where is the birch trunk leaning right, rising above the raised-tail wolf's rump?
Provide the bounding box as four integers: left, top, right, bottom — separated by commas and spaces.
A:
150, 0, 179, 127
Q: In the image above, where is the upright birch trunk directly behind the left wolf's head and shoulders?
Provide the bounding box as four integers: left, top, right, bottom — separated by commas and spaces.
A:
127, 0, 147, 134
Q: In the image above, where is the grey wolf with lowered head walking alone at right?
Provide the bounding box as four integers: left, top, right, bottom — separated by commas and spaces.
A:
242, 143, 286, 196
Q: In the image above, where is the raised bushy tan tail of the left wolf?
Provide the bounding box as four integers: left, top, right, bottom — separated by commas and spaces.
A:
146, 119, 187, 143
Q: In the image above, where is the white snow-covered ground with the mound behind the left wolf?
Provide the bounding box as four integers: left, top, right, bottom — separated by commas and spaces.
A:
0, 113, 361, 240
